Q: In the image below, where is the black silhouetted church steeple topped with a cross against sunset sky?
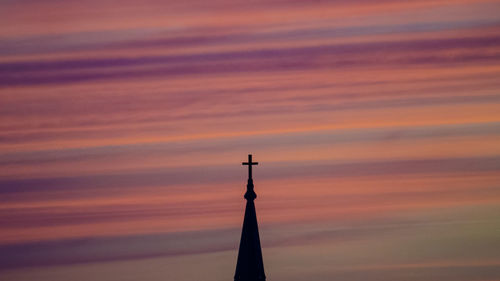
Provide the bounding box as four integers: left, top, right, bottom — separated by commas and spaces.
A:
234, 154, 266, 281
